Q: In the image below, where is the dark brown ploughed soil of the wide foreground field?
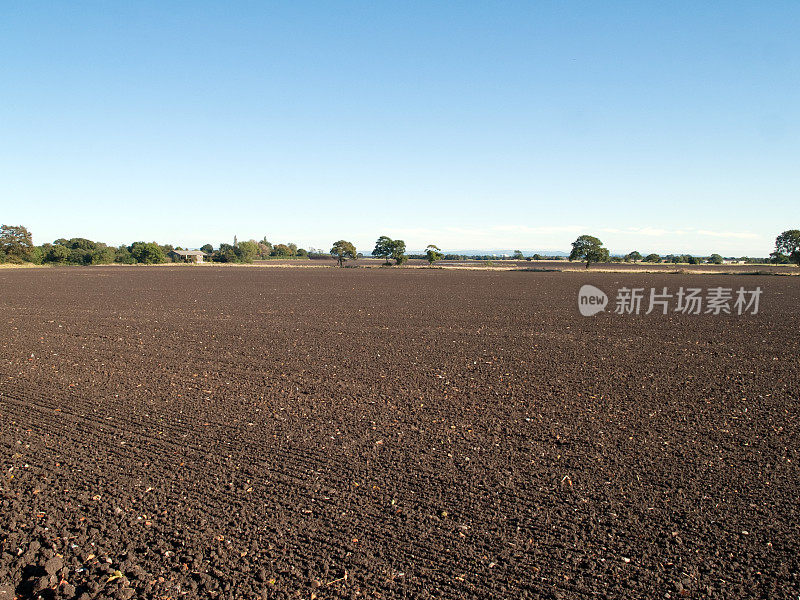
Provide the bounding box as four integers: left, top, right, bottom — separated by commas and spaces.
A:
0, 267, 800, 600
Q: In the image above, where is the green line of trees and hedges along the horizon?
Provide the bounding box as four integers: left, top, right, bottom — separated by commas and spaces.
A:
0, 225, 800, 268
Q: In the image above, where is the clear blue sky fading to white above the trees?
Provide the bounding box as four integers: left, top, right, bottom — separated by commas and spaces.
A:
0, 0, 800, 256
